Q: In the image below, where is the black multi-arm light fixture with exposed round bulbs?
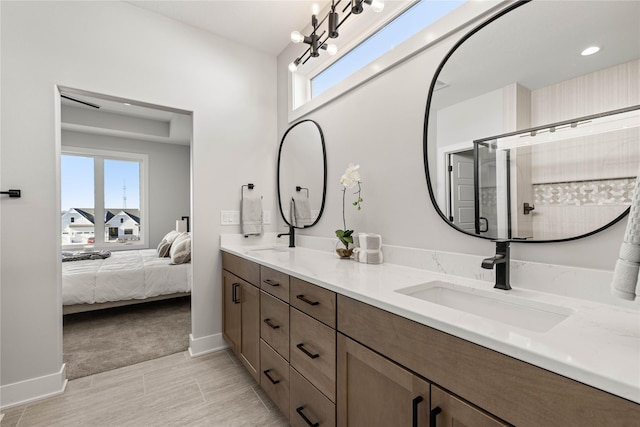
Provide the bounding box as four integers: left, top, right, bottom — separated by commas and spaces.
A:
289, 0, 384, 73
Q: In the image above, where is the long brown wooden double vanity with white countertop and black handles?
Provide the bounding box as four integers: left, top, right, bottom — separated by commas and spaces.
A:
222, 242, 640, 426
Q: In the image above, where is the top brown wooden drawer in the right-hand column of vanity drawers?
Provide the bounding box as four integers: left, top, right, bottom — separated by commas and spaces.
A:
289, 277, 336, 328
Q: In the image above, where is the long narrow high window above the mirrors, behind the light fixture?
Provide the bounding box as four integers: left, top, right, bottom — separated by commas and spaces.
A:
288, 0, 501, 122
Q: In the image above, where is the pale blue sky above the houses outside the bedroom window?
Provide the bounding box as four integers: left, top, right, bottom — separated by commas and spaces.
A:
60, 155, 140, 211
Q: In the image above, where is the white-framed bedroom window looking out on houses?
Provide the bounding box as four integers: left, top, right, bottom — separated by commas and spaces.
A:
60, 147, 148, 249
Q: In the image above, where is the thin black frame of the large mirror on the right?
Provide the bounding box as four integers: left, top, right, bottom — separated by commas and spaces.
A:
422, 0, 638, 243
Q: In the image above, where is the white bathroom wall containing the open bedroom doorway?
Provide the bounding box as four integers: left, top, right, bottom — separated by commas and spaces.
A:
0, 1, 277, 405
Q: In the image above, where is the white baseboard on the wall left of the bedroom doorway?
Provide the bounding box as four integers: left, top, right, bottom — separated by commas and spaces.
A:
0, 363, 67, 409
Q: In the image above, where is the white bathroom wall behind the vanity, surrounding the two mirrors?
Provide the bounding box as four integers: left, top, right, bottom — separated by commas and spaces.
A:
278, 10, 625, 270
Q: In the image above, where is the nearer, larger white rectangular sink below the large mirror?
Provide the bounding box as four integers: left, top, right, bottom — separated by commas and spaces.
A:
396, 281, 573, 332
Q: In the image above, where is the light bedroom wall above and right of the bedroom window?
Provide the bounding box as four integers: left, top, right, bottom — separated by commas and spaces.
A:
62, 131, 191, 248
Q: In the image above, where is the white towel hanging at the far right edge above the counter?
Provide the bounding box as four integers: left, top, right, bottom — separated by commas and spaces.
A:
611, 179, 640, 301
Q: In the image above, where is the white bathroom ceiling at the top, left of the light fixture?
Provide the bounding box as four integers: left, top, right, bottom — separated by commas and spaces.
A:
125, 0, 329, 55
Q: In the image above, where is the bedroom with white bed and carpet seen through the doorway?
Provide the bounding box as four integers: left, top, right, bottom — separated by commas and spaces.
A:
60, 93, 192, 379
